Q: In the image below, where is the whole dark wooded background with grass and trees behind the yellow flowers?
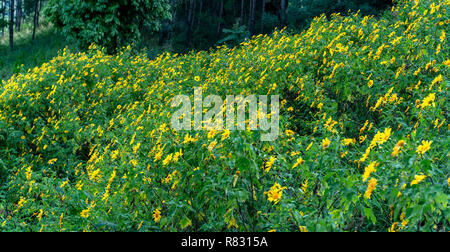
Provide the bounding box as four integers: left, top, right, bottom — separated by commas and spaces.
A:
0, 0, 392, 79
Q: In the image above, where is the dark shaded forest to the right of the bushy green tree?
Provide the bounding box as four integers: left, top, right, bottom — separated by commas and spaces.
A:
160, 0, 392, 52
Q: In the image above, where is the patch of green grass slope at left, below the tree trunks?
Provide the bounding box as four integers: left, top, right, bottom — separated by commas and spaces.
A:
0, 23, 74, 80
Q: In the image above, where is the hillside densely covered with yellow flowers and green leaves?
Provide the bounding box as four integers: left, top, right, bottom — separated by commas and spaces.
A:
0, 0, 450, 232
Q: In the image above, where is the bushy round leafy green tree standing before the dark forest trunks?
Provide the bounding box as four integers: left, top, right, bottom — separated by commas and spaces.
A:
46, 0, 171, 53
